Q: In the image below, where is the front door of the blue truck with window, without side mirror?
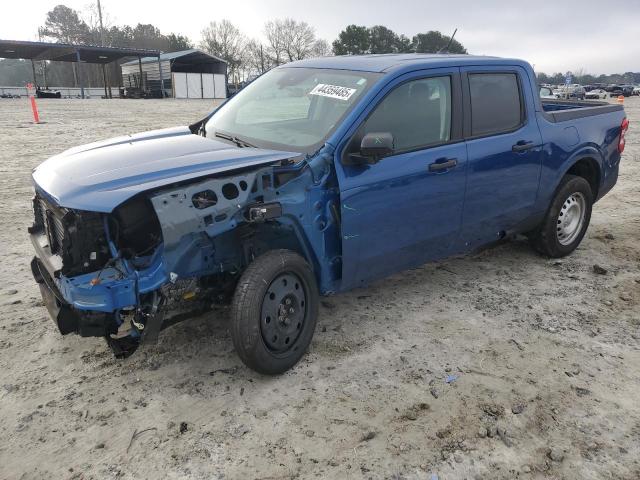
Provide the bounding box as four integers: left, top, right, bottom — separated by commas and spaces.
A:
336, 69, 467, 288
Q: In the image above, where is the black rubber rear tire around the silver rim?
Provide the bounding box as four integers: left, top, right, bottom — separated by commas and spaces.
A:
529, 175, 593, 258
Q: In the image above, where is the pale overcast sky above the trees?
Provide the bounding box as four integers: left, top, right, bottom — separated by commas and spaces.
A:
0, 0, 640, 74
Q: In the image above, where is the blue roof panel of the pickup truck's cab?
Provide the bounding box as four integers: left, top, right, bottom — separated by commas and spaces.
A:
286, 53, 527, 72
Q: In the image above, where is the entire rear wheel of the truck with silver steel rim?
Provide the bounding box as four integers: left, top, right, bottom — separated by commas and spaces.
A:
529, 175, 593, 258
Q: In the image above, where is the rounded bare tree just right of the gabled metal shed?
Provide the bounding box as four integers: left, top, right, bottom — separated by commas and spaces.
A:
200, 20, 247, 83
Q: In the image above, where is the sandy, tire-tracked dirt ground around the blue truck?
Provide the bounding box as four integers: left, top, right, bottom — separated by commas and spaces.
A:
0, 98, 640, 480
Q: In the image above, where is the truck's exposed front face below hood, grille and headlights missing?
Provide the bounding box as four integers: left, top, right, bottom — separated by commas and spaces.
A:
29, 190, 182, 356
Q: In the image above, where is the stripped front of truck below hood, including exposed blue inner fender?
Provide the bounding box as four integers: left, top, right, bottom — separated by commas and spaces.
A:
29, 168, 293, 357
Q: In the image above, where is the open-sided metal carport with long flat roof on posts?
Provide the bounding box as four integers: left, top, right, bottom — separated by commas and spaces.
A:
0, 40, 162, 98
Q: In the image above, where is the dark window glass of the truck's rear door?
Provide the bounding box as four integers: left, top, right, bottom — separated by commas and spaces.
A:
469, 73, 524, 137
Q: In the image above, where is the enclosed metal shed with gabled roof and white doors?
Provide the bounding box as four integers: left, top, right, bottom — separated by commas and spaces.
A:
121, 48, 227, 98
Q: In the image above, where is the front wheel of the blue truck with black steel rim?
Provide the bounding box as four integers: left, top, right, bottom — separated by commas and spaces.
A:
231, 250, 319, 375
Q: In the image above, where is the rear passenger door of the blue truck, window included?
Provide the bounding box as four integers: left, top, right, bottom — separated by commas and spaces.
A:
460, 66, 542, 249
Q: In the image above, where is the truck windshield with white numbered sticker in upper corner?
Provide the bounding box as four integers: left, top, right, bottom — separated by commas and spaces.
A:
205, 67, 380, 153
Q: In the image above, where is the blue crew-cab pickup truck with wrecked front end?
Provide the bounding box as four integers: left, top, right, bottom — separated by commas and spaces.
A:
29, 54, 628, 374
